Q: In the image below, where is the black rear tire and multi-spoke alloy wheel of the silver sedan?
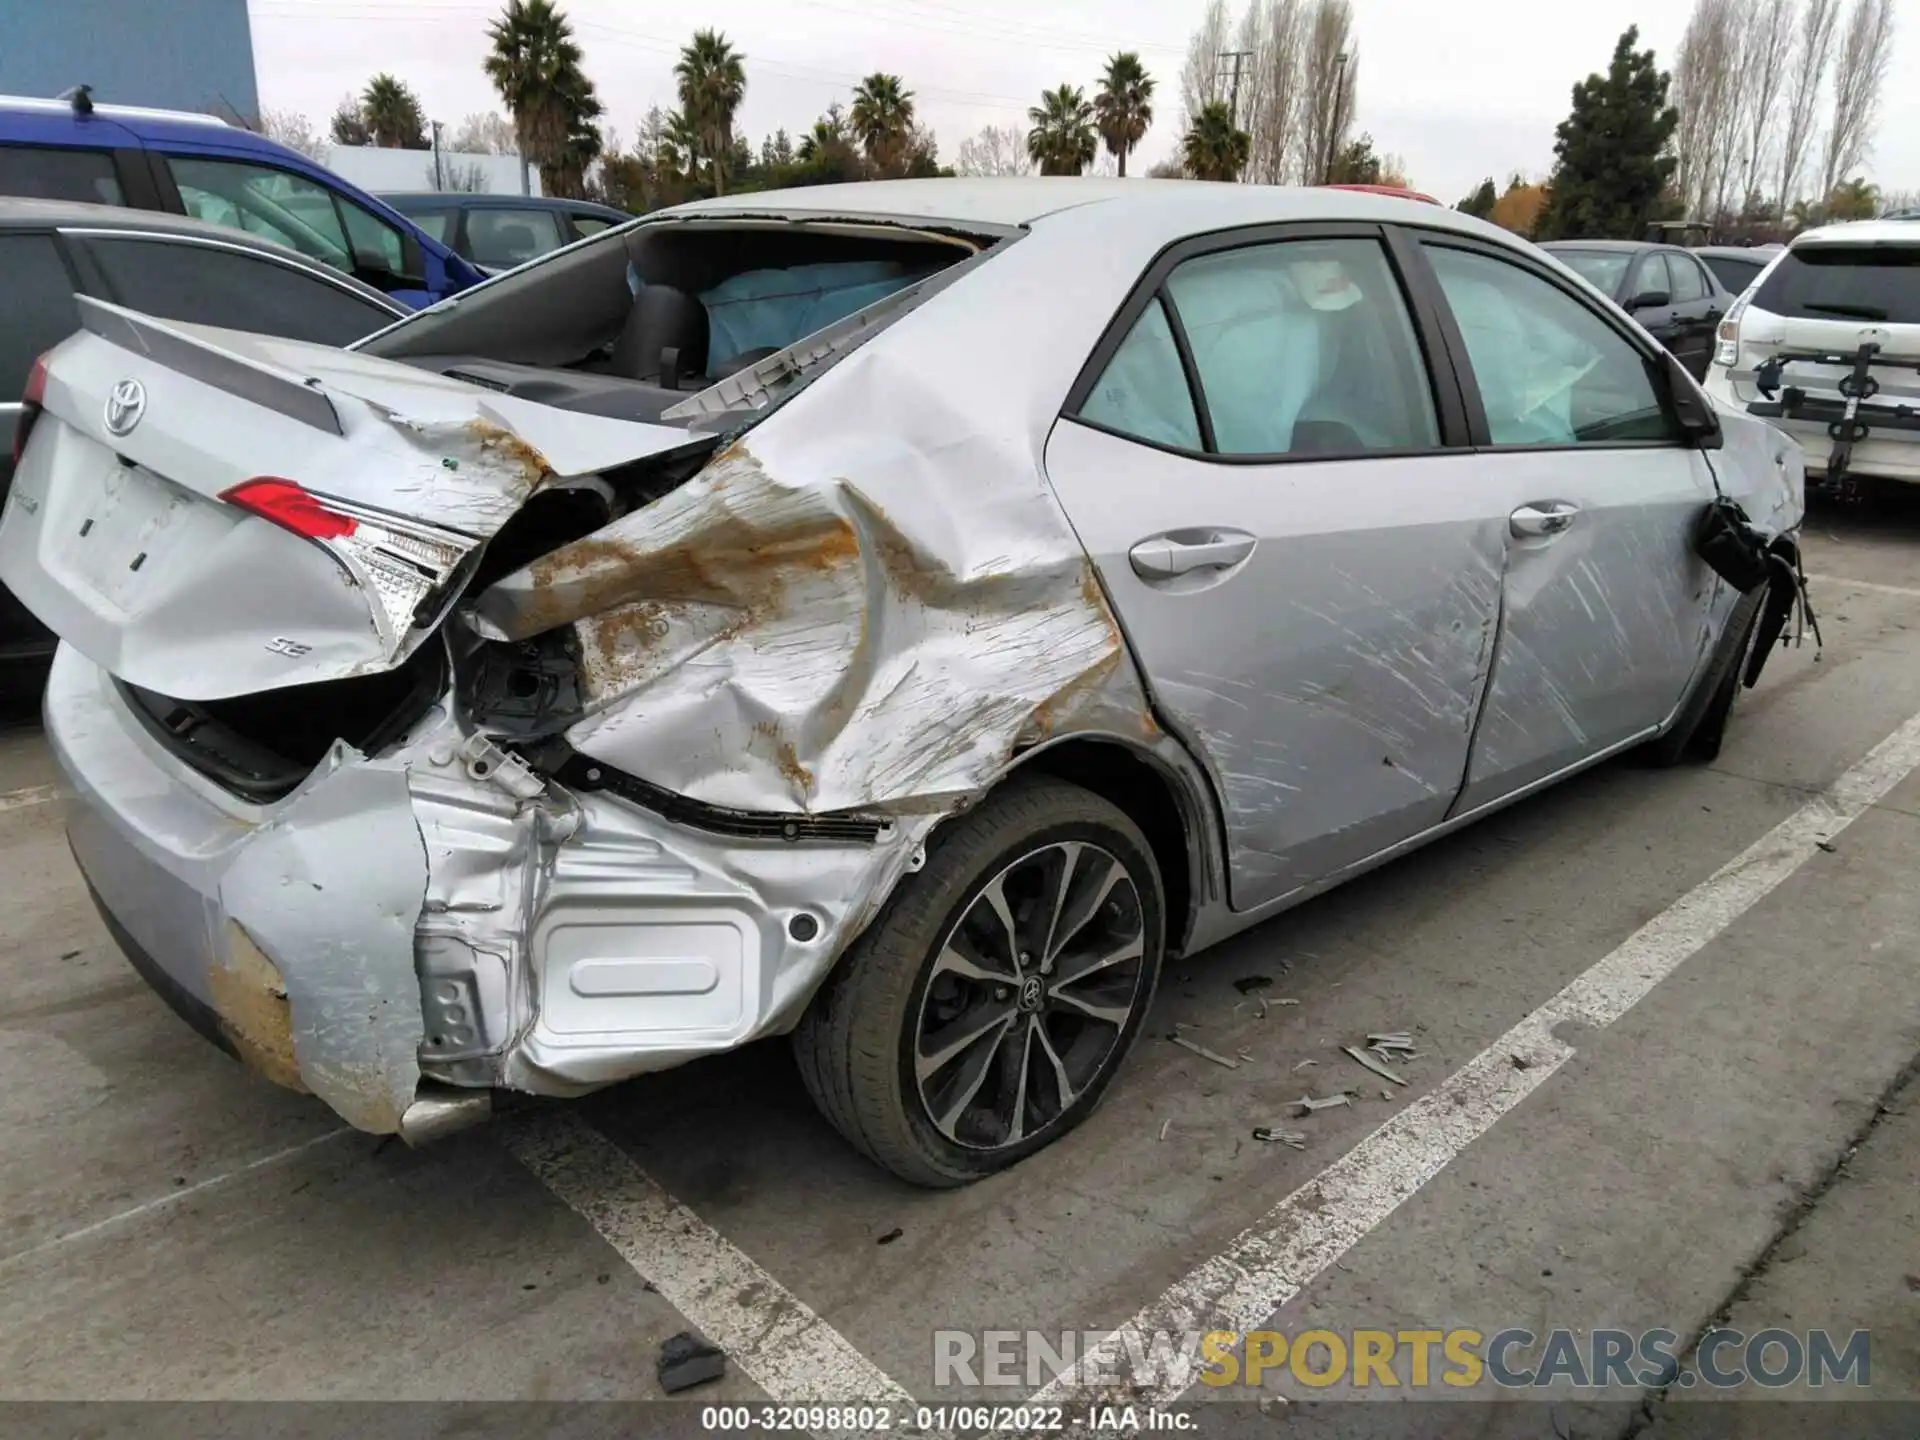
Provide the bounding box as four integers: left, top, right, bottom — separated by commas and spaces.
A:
793, 778, 1165, 1188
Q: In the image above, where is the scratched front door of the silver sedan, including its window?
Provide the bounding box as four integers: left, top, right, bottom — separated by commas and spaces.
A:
1421, 236, 1718, 812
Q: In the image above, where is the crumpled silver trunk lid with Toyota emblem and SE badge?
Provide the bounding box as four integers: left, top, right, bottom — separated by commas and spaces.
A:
0, 300, 706, 701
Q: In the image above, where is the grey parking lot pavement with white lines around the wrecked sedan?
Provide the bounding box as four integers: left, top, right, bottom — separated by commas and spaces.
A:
0, 509, 1920, 1436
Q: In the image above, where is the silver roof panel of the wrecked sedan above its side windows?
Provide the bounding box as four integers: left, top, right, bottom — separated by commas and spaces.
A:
668, 175, 1536, 242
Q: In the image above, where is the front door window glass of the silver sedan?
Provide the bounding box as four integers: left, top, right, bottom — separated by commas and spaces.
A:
1425, 242, 1678, 445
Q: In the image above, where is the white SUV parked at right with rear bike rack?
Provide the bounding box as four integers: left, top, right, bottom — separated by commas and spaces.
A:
1707, 221, 1920, 493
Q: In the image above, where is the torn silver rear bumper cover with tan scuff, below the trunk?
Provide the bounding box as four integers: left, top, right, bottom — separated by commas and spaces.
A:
44, 649, 426, 1133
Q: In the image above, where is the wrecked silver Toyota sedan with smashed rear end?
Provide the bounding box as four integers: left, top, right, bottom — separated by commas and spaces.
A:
0, 179, 1803, 1185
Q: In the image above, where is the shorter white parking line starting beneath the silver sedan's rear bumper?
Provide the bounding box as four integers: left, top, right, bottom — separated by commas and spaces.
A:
507, 1112, 912, 1405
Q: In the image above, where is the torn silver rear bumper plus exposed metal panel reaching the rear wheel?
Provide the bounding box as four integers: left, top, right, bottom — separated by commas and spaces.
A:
46, 647, 933, 1133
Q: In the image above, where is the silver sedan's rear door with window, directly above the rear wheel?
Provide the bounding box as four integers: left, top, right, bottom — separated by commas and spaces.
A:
1046, 227, 1507, 910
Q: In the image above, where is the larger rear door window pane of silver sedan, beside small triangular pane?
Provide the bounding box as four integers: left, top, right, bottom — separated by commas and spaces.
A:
1167, 240, 1440, 455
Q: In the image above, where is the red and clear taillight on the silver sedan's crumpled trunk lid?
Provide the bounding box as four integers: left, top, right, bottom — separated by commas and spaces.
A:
221, 474, 474, 641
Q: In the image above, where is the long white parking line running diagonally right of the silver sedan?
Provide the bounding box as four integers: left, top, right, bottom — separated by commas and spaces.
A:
1033, 714, 1920, 1404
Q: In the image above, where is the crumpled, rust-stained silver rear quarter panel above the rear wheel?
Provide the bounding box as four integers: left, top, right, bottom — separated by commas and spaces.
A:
478, 337, 1158, 812
